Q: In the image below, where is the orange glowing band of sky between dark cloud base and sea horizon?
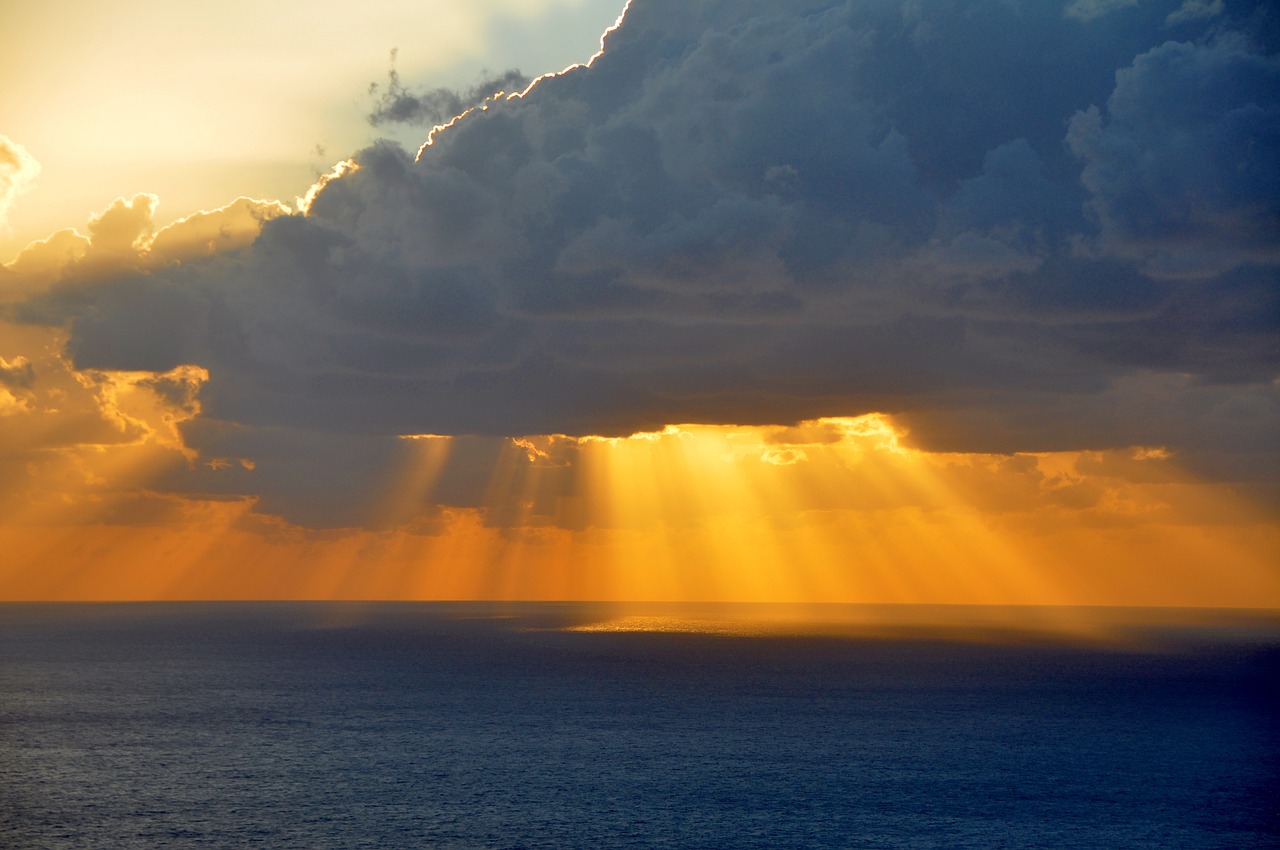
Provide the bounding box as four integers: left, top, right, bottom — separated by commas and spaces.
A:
0, 394, 1280, 607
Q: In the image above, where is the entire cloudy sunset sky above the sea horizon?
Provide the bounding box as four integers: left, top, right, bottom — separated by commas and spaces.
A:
0, 0, 1280, 608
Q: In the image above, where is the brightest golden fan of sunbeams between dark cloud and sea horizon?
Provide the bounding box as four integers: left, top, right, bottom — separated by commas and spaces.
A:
565, 415, 1059, 603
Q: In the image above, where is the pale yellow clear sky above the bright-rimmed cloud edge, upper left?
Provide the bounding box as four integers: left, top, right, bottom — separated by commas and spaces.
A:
0, 0, 623, 262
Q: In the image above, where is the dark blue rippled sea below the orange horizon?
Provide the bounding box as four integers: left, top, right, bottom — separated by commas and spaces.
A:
0, 604, 1280, 850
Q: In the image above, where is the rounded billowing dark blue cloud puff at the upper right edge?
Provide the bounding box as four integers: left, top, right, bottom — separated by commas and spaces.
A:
1068, 37, 1280, 277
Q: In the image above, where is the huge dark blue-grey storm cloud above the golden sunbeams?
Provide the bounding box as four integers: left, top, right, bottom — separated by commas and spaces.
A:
18, 0, 1280, 517
